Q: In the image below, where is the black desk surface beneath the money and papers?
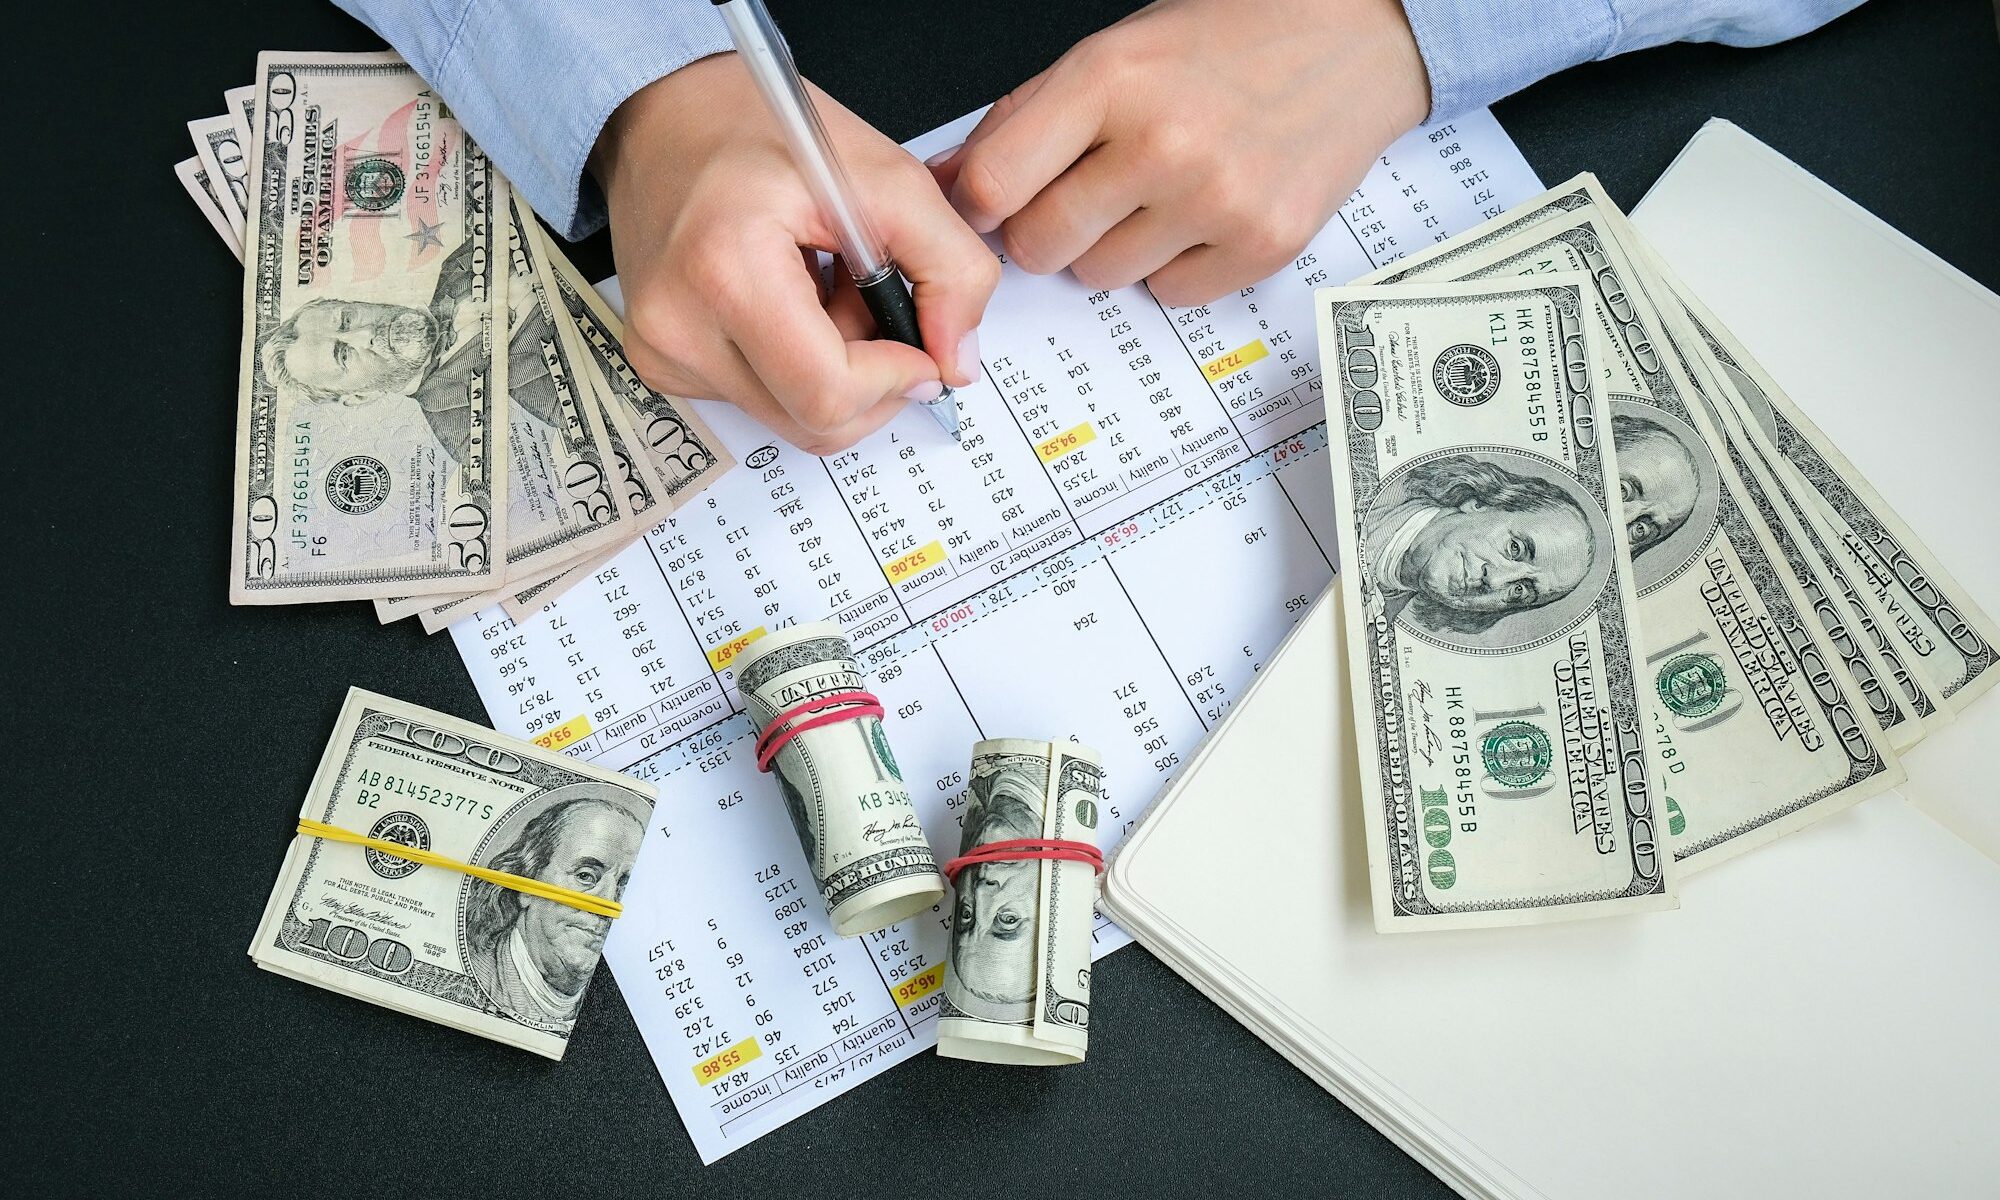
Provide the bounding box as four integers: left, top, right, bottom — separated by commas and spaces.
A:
15, 0, 2000, 1196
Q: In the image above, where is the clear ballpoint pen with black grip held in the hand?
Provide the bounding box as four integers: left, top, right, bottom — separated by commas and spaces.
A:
714, 0, 958, 438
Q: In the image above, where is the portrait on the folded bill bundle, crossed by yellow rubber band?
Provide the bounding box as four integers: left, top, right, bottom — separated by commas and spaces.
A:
466, 794, 646, 1028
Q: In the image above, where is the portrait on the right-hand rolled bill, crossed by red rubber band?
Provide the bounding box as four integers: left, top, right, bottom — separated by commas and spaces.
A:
946, 764, 1048, 1022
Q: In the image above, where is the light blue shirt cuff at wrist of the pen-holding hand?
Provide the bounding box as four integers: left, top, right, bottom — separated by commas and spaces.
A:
432, 0, 730, 240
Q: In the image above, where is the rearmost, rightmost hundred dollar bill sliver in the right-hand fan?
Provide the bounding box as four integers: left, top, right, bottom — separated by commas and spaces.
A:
1648, 256, 2000, 714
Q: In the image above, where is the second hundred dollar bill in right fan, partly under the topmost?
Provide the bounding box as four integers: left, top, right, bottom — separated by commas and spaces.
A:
1376, 182, 1904, 870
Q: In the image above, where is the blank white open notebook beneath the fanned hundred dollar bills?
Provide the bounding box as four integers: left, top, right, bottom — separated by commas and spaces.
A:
1102, 122, 2000, 1198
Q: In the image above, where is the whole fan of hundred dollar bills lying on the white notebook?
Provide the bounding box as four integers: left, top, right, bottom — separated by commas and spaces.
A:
1316, 174, 2000, 932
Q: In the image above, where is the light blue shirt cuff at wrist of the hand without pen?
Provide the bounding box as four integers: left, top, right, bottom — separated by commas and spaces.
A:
1402, 0, 1616, 120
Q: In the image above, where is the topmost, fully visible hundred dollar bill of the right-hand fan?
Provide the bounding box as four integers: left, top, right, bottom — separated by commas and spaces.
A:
1314, 272, 1674, 932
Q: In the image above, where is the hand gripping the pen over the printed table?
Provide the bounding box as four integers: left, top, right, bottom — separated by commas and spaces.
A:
590, 54, 1000, 454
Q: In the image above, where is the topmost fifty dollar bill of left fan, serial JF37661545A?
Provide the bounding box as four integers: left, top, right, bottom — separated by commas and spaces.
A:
230, 52, 508, 604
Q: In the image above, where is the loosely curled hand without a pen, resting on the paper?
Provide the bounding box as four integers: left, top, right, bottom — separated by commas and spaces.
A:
934, 0, 1430, 304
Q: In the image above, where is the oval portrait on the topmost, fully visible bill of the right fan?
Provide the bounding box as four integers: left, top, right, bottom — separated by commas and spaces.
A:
1362, 454, 1600, 634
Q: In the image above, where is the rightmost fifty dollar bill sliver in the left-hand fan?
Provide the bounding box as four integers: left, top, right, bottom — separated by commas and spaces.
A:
540, 236, 736, 502
